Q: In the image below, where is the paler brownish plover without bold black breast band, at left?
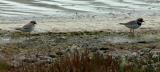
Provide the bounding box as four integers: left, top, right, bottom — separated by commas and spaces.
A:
15, 21, 37, 32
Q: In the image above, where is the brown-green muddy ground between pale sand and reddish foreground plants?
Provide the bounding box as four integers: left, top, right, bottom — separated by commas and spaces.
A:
0, 30, 160, 66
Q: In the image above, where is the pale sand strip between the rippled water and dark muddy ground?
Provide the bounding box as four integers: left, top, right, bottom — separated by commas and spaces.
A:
0, 14, 160, 32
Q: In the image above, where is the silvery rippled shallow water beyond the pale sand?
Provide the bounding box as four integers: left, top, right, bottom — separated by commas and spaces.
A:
0, 0, 160, 16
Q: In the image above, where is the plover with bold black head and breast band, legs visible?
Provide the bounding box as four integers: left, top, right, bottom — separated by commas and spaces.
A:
120, 18, 144, 33
